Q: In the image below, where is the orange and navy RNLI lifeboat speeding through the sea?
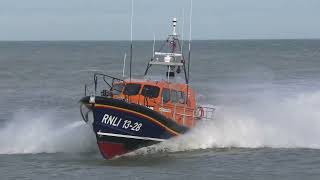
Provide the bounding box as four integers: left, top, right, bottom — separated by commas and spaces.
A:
80, 18, 214, 159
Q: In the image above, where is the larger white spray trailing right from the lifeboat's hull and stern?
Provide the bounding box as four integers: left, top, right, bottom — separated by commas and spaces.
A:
129, 92, 320, 155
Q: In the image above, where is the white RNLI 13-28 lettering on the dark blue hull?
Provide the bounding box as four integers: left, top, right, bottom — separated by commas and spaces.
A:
101, 114, 142, 132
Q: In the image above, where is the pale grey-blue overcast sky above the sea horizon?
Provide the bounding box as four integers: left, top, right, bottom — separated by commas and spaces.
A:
0, 0, 320, 40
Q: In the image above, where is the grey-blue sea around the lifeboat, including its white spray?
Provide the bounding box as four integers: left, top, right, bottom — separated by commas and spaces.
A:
0, 40, 320, 180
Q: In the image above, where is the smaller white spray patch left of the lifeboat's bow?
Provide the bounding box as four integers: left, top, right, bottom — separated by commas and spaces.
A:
0, 110, 96, 154
